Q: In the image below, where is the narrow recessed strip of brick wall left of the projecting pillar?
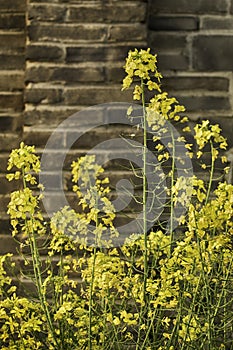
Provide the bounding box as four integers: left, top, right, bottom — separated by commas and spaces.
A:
0, 0, 26, 246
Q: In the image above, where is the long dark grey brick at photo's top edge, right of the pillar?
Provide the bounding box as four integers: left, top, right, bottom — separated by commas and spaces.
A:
150, 0, 228, 14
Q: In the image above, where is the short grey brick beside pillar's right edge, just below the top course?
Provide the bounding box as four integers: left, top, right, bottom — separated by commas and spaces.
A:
148, 15, 199, 31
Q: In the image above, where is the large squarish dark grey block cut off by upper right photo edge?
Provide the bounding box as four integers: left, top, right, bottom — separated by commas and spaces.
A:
193, 35, 233, 71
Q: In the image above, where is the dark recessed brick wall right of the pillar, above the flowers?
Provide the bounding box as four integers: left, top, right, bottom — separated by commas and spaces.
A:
148, 0, 233, 147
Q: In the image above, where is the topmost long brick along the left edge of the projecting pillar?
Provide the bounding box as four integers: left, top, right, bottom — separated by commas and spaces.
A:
28, 22, 107, 42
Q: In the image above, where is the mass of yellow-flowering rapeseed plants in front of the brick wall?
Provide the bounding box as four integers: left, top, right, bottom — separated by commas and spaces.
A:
0, 49, 233, 350
